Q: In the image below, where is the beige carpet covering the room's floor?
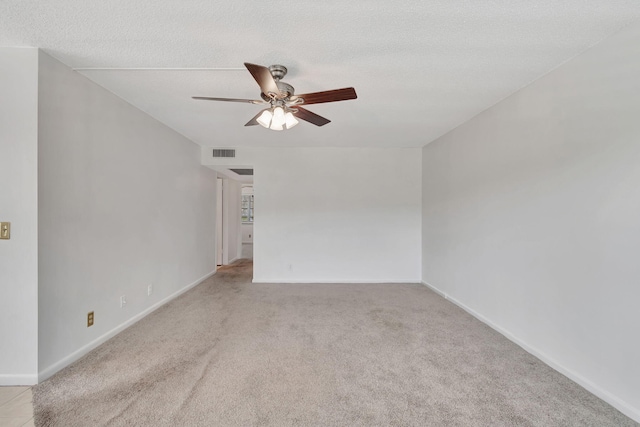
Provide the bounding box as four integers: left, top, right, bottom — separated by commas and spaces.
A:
34, 261, 637, 427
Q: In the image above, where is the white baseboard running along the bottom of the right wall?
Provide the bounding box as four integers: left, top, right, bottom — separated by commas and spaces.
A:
422, 281, 640, 422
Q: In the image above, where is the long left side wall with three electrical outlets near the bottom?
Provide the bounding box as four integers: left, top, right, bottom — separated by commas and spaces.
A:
38, 53, 216, 379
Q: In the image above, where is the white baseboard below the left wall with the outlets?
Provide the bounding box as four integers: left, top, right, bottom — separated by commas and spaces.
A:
38, 270, 216, 384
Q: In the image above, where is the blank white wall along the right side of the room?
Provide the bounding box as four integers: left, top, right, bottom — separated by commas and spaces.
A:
422, 22, 640, 421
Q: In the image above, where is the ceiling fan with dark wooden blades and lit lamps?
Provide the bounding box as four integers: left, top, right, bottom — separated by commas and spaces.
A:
192, 62, 358, 130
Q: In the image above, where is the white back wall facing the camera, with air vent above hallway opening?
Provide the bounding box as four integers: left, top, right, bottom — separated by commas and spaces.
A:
202, 147, 422, 282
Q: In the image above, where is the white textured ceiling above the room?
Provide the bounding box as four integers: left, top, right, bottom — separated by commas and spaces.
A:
0, 0, 640, 147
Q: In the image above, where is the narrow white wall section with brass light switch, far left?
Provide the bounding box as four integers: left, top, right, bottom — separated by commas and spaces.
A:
0, 48, 38, 385
